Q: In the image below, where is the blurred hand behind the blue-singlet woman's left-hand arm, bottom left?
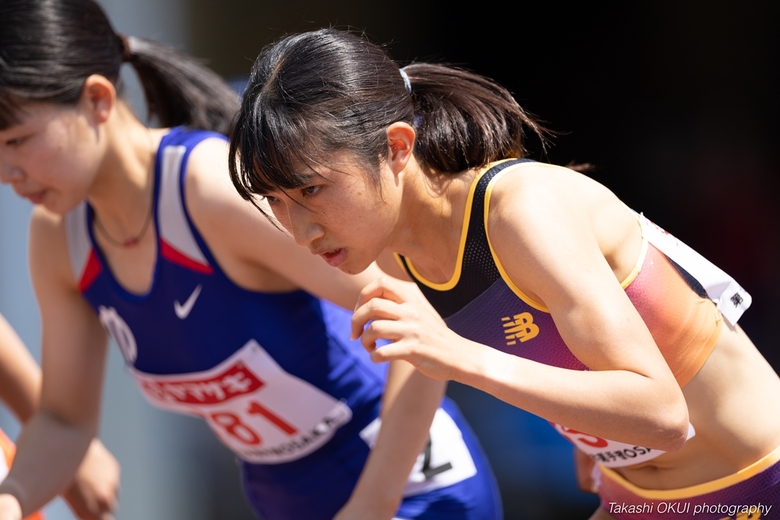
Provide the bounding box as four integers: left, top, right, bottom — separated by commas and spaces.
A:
62, 439, 119, 520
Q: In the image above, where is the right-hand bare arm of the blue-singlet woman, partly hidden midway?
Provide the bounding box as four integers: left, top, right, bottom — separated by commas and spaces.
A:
187, 141, 445, 520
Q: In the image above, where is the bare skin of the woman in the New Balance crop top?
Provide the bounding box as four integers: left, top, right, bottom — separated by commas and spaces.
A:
260, 123, 780, 508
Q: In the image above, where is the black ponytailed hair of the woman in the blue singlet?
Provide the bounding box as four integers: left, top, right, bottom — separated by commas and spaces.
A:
0, 0, 239, 133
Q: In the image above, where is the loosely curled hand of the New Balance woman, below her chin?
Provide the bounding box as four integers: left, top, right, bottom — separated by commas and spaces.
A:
352, 276, 474, 380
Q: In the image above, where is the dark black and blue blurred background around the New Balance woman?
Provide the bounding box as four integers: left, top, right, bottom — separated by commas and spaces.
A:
186, 0, 780, 519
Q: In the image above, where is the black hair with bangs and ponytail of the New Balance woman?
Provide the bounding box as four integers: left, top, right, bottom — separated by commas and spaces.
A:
230, 29, 545, 200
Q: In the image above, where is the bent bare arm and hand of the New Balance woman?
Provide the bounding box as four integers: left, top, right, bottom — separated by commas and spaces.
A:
353, 166, 688, 450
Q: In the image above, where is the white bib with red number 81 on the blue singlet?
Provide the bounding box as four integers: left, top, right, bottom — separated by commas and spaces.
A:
128, 340, 352, 464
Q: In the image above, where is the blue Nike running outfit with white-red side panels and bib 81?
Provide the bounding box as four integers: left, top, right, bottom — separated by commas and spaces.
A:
66, 128, 501, 520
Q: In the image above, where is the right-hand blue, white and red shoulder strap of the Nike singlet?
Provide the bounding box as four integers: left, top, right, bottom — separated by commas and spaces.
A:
156, 129, 225, 274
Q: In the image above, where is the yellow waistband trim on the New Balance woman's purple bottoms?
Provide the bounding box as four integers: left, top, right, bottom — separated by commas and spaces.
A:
599, 446, 780, 500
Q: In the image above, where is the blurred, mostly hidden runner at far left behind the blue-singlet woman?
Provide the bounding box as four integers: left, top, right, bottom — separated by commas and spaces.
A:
0, 315, 119, 520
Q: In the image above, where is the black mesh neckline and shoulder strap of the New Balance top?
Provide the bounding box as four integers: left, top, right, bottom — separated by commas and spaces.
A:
398, 159, 533, 318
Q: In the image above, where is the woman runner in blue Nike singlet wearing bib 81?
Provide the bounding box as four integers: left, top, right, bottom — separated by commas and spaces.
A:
0, 4, 500, 520
